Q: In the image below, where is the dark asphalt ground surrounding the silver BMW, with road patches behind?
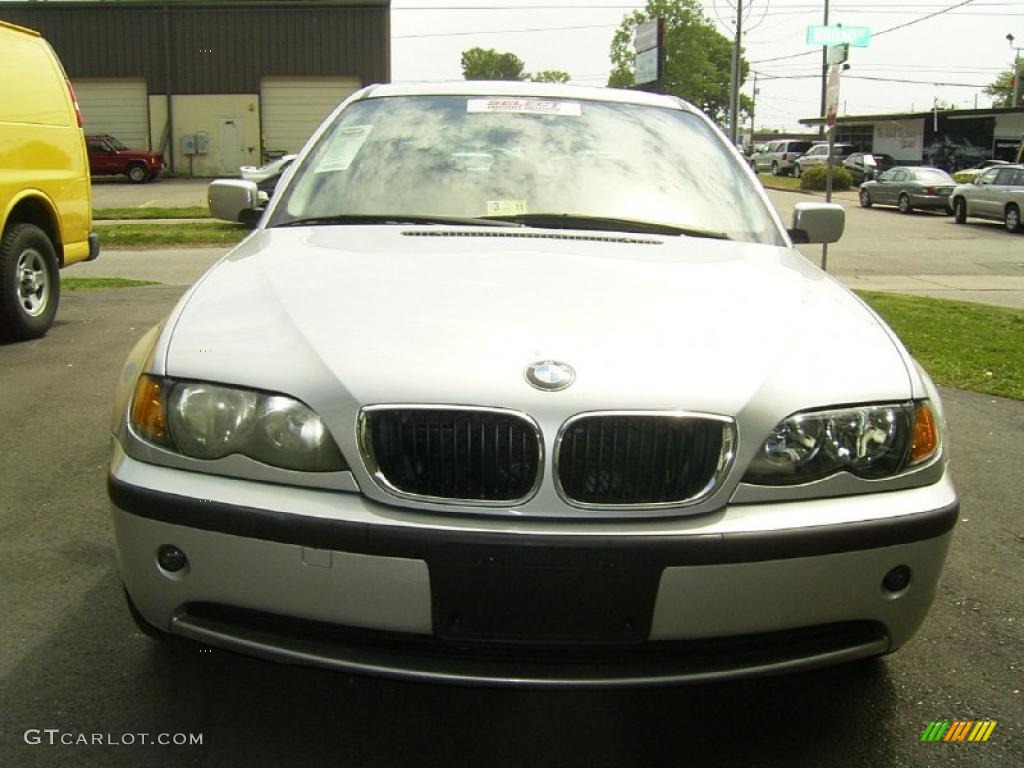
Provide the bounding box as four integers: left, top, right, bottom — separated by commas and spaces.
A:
0, 174, 1024, 768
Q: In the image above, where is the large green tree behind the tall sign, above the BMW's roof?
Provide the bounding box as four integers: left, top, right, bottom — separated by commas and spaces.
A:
608, 0, 751, 124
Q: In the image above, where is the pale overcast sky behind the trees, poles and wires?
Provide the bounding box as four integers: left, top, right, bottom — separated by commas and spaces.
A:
391, 0, 1024, 130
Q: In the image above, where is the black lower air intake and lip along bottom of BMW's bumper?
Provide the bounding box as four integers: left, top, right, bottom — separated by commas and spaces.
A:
172, 603, 890, 687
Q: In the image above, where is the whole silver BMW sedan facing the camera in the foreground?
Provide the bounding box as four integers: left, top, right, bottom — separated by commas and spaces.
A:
109, 81, 957, 686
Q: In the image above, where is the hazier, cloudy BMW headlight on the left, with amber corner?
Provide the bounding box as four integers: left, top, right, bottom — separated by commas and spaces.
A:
129, 376, 347, 472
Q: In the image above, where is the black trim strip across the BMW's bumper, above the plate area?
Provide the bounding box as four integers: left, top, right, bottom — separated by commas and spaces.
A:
108, 476, 959, 567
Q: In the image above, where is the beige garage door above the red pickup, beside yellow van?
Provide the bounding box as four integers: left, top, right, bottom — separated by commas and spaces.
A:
72, 78, 150, 150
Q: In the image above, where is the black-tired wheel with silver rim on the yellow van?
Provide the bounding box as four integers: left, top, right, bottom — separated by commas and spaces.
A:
0, 224, 60, 340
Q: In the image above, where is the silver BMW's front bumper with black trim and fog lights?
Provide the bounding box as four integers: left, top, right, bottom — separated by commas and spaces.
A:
110, 455, 958, 686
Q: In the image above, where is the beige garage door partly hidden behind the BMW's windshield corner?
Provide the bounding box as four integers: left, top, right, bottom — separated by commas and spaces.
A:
260, 78, 361, 153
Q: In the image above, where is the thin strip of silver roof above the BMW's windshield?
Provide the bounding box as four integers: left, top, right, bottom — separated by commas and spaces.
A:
361, 80, 697, 112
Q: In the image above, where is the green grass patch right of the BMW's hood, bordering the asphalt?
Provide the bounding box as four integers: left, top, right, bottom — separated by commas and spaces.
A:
857, 291, 1024, 400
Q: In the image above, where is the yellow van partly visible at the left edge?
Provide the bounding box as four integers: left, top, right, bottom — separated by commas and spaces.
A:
0, 22, 99, 339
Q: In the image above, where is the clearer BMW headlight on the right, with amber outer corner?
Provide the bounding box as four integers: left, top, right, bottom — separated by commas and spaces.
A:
743, 400, 939, 485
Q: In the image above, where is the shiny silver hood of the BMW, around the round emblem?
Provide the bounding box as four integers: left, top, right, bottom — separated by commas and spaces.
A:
164, 225, 913, 418
